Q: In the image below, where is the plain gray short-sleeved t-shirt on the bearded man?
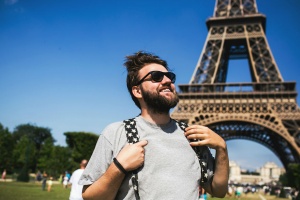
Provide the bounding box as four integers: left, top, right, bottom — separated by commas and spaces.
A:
79, 116, 212, 200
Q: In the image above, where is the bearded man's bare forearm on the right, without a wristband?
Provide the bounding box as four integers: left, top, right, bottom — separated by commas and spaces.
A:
211, 147, 229, 198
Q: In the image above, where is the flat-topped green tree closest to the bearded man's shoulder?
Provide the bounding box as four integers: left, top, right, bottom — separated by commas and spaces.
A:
64, 132, 99, 166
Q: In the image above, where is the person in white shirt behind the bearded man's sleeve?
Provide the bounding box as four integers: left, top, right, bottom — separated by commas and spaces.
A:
69, 160, 88, 200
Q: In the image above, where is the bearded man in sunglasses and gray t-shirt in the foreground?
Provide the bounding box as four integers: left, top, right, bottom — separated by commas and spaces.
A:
80, 52, 229, 200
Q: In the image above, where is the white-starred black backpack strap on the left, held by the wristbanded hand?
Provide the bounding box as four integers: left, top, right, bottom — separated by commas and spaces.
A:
123, 118, 141, 200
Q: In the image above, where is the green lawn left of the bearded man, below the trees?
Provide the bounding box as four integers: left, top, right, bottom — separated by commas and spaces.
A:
0, 182, 70, 200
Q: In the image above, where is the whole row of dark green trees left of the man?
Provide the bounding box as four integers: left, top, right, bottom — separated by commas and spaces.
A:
0, 123, 98, 182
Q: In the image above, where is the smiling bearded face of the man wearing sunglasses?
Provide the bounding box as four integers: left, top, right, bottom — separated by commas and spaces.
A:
140, 64, 179, 113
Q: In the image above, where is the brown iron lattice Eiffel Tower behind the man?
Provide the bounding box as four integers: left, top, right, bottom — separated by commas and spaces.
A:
171, 0, 300, 169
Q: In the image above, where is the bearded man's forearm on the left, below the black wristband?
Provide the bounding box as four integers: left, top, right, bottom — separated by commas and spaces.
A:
82, 163, 125, 200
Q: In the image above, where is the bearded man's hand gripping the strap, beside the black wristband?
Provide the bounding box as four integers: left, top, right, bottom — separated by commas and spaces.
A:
116, 140, 148, 171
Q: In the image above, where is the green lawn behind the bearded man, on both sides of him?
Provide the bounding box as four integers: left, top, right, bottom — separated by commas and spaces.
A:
0, 182, 289, 200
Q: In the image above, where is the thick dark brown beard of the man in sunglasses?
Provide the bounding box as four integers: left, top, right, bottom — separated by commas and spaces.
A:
141, 87, 179, 114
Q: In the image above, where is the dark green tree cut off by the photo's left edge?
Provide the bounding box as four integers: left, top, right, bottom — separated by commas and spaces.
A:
0, 123, 14, 172
